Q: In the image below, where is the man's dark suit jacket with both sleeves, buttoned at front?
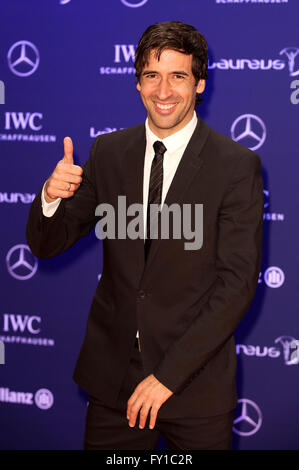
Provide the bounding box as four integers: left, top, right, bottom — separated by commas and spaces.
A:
27, 118, 263, 417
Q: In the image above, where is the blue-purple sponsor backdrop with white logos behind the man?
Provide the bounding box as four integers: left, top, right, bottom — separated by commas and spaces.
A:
0, 0, 299, 449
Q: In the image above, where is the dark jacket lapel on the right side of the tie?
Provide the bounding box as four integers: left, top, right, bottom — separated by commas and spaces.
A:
144, 116, 209, 274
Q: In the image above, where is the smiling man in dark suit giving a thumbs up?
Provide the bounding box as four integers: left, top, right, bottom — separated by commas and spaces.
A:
27, 22, 263, 450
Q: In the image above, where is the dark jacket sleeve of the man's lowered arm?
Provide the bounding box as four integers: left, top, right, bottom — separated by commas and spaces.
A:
153, 152, 264, 393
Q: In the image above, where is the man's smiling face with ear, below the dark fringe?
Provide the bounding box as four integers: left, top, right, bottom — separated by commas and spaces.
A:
137, 49, 205, 139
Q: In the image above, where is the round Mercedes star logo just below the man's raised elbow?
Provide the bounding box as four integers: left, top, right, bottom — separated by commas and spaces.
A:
6, 244, 38, 281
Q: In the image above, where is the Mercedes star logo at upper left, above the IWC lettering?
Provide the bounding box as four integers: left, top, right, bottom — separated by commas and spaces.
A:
7, 41, 39, 77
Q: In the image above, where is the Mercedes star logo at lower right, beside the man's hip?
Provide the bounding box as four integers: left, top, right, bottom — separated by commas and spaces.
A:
233, 398, 263, 436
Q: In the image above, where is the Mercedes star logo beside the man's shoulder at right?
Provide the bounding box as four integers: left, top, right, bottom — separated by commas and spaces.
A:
231, 114, 266, 150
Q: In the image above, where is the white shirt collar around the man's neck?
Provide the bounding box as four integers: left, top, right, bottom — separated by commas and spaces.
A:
145, 111, 197, 153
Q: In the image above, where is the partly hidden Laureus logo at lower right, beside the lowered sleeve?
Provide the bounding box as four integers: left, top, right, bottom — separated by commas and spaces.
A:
236, 335, 299, 366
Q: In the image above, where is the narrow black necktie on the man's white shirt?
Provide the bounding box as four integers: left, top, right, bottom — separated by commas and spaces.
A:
144, 140, 166, 259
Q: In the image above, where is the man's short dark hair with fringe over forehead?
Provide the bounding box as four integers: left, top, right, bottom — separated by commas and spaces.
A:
135, 21, 208, 105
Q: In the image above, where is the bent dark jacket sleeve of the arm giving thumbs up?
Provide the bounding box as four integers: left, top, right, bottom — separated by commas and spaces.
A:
26, 140, 98, 258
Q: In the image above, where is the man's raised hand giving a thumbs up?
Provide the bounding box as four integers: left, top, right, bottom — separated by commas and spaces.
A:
44, 137, 83, 202
